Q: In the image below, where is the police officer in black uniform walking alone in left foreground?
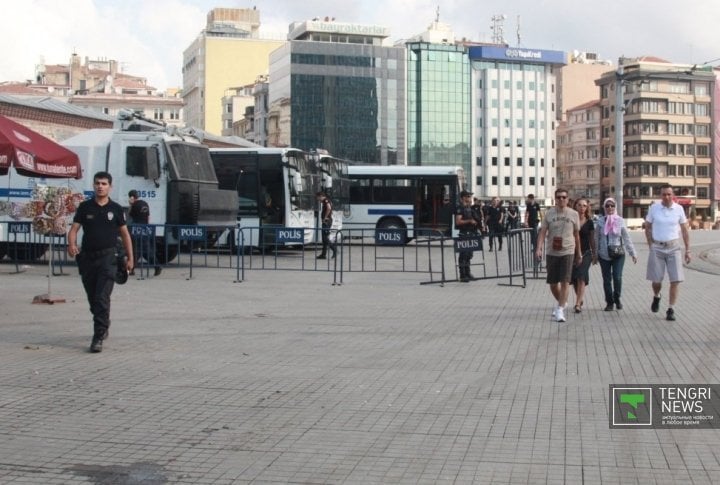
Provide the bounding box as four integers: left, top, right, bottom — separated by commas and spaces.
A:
67, 172, 135, 352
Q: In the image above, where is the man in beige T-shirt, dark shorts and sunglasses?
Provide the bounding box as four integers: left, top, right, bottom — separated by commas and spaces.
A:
535, 189, 582, 322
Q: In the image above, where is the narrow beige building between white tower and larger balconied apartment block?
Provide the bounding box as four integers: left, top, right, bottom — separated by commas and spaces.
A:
557, 99, 602, 203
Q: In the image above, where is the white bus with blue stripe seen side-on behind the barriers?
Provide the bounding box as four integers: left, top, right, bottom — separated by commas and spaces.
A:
343, 165, 465, 240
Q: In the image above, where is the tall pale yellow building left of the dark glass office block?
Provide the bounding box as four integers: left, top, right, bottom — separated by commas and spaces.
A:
182, 8, 285, 135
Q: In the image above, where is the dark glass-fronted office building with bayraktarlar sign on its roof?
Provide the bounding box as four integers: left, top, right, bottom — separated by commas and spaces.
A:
270, 21, 406, 165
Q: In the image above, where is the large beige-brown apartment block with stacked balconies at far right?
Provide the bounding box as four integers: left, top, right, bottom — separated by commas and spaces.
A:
596, 57, 717, 221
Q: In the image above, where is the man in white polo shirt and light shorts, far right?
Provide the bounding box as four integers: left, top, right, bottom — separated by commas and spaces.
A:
645, 184, 690, 321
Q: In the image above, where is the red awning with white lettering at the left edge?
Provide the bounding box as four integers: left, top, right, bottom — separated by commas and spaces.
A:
0, 115, 82, 179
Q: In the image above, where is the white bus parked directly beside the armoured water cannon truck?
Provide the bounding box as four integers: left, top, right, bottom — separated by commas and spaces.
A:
210, 147, 321, 249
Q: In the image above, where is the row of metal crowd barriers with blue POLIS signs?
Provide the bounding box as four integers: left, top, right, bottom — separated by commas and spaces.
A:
0, 222, 542, 287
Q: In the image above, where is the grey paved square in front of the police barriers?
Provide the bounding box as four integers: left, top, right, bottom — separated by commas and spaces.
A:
0, 231, 720, 484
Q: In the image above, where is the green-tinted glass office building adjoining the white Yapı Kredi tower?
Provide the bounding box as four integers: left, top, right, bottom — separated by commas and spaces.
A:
406, 42, 471, 175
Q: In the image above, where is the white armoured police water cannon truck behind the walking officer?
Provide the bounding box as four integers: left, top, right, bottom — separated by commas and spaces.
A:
0, 110, 238, 263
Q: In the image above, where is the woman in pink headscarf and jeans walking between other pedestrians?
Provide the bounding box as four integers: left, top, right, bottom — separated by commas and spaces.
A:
595, 198, 637, 312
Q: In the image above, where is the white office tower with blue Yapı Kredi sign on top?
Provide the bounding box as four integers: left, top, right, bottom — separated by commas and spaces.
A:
468, 45, 566, 201
